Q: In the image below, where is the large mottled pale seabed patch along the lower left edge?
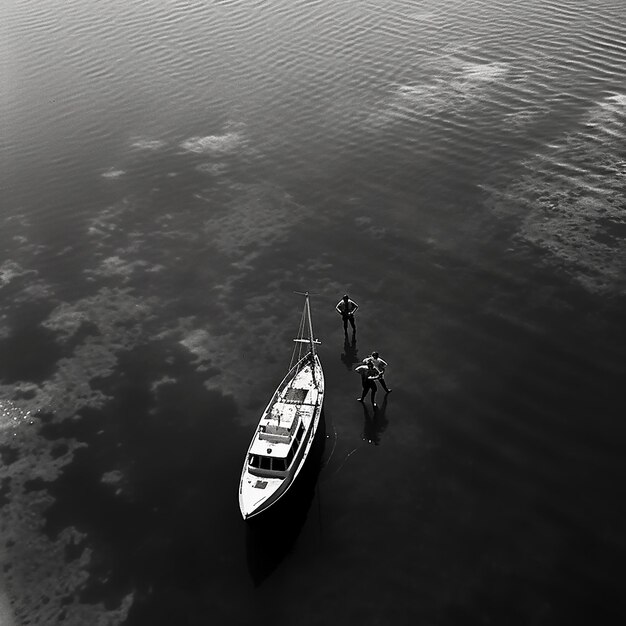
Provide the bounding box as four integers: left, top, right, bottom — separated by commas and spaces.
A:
0, 288, 166, 626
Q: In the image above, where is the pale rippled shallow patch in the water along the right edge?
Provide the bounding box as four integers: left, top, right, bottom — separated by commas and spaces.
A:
491, 96, 626, 294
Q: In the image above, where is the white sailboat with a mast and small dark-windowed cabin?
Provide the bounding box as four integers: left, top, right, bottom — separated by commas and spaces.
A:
239, 292, 324, 520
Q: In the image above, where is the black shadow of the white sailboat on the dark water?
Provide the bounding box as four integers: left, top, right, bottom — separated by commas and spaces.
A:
246, 409, 326, 586
